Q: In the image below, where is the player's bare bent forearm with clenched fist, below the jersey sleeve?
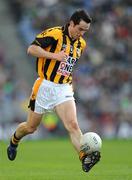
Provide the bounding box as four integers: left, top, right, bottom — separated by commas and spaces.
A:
27, 44, 67, 61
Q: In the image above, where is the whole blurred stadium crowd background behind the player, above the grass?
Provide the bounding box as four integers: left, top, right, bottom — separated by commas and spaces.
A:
0, 0, 132, 140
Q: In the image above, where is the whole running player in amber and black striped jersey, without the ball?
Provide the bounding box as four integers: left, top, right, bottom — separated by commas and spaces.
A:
7, 10, 100, 172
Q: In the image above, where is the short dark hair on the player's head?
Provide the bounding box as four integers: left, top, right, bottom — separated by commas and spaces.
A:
70, 10, 92, 25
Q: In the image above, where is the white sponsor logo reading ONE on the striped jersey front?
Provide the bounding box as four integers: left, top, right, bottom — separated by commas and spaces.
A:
57, 56, 77, 76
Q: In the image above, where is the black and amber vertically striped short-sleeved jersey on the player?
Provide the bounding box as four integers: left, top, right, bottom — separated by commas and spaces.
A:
32, 24, 86, 84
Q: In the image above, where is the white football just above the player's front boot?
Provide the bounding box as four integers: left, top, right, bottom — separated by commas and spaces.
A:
80, 132, 102, 154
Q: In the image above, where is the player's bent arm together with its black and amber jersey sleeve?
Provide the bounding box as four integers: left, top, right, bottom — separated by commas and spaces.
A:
27, 28, 67, 61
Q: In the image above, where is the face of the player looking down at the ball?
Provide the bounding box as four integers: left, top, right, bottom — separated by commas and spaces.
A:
69, 20, 90, 39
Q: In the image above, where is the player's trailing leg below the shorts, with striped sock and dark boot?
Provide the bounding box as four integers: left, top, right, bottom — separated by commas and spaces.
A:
7, 110, 42, 161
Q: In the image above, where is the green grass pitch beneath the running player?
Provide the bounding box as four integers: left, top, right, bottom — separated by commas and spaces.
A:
0, 139, 132, 180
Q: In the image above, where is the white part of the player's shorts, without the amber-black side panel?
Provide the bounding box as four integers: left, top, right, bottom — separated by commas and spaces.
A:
34, 79, 74, 114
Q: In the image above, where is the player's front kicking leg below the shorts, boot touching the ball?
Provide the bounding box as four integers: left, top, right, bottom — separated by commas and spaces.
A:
55, 100, 100, 172
